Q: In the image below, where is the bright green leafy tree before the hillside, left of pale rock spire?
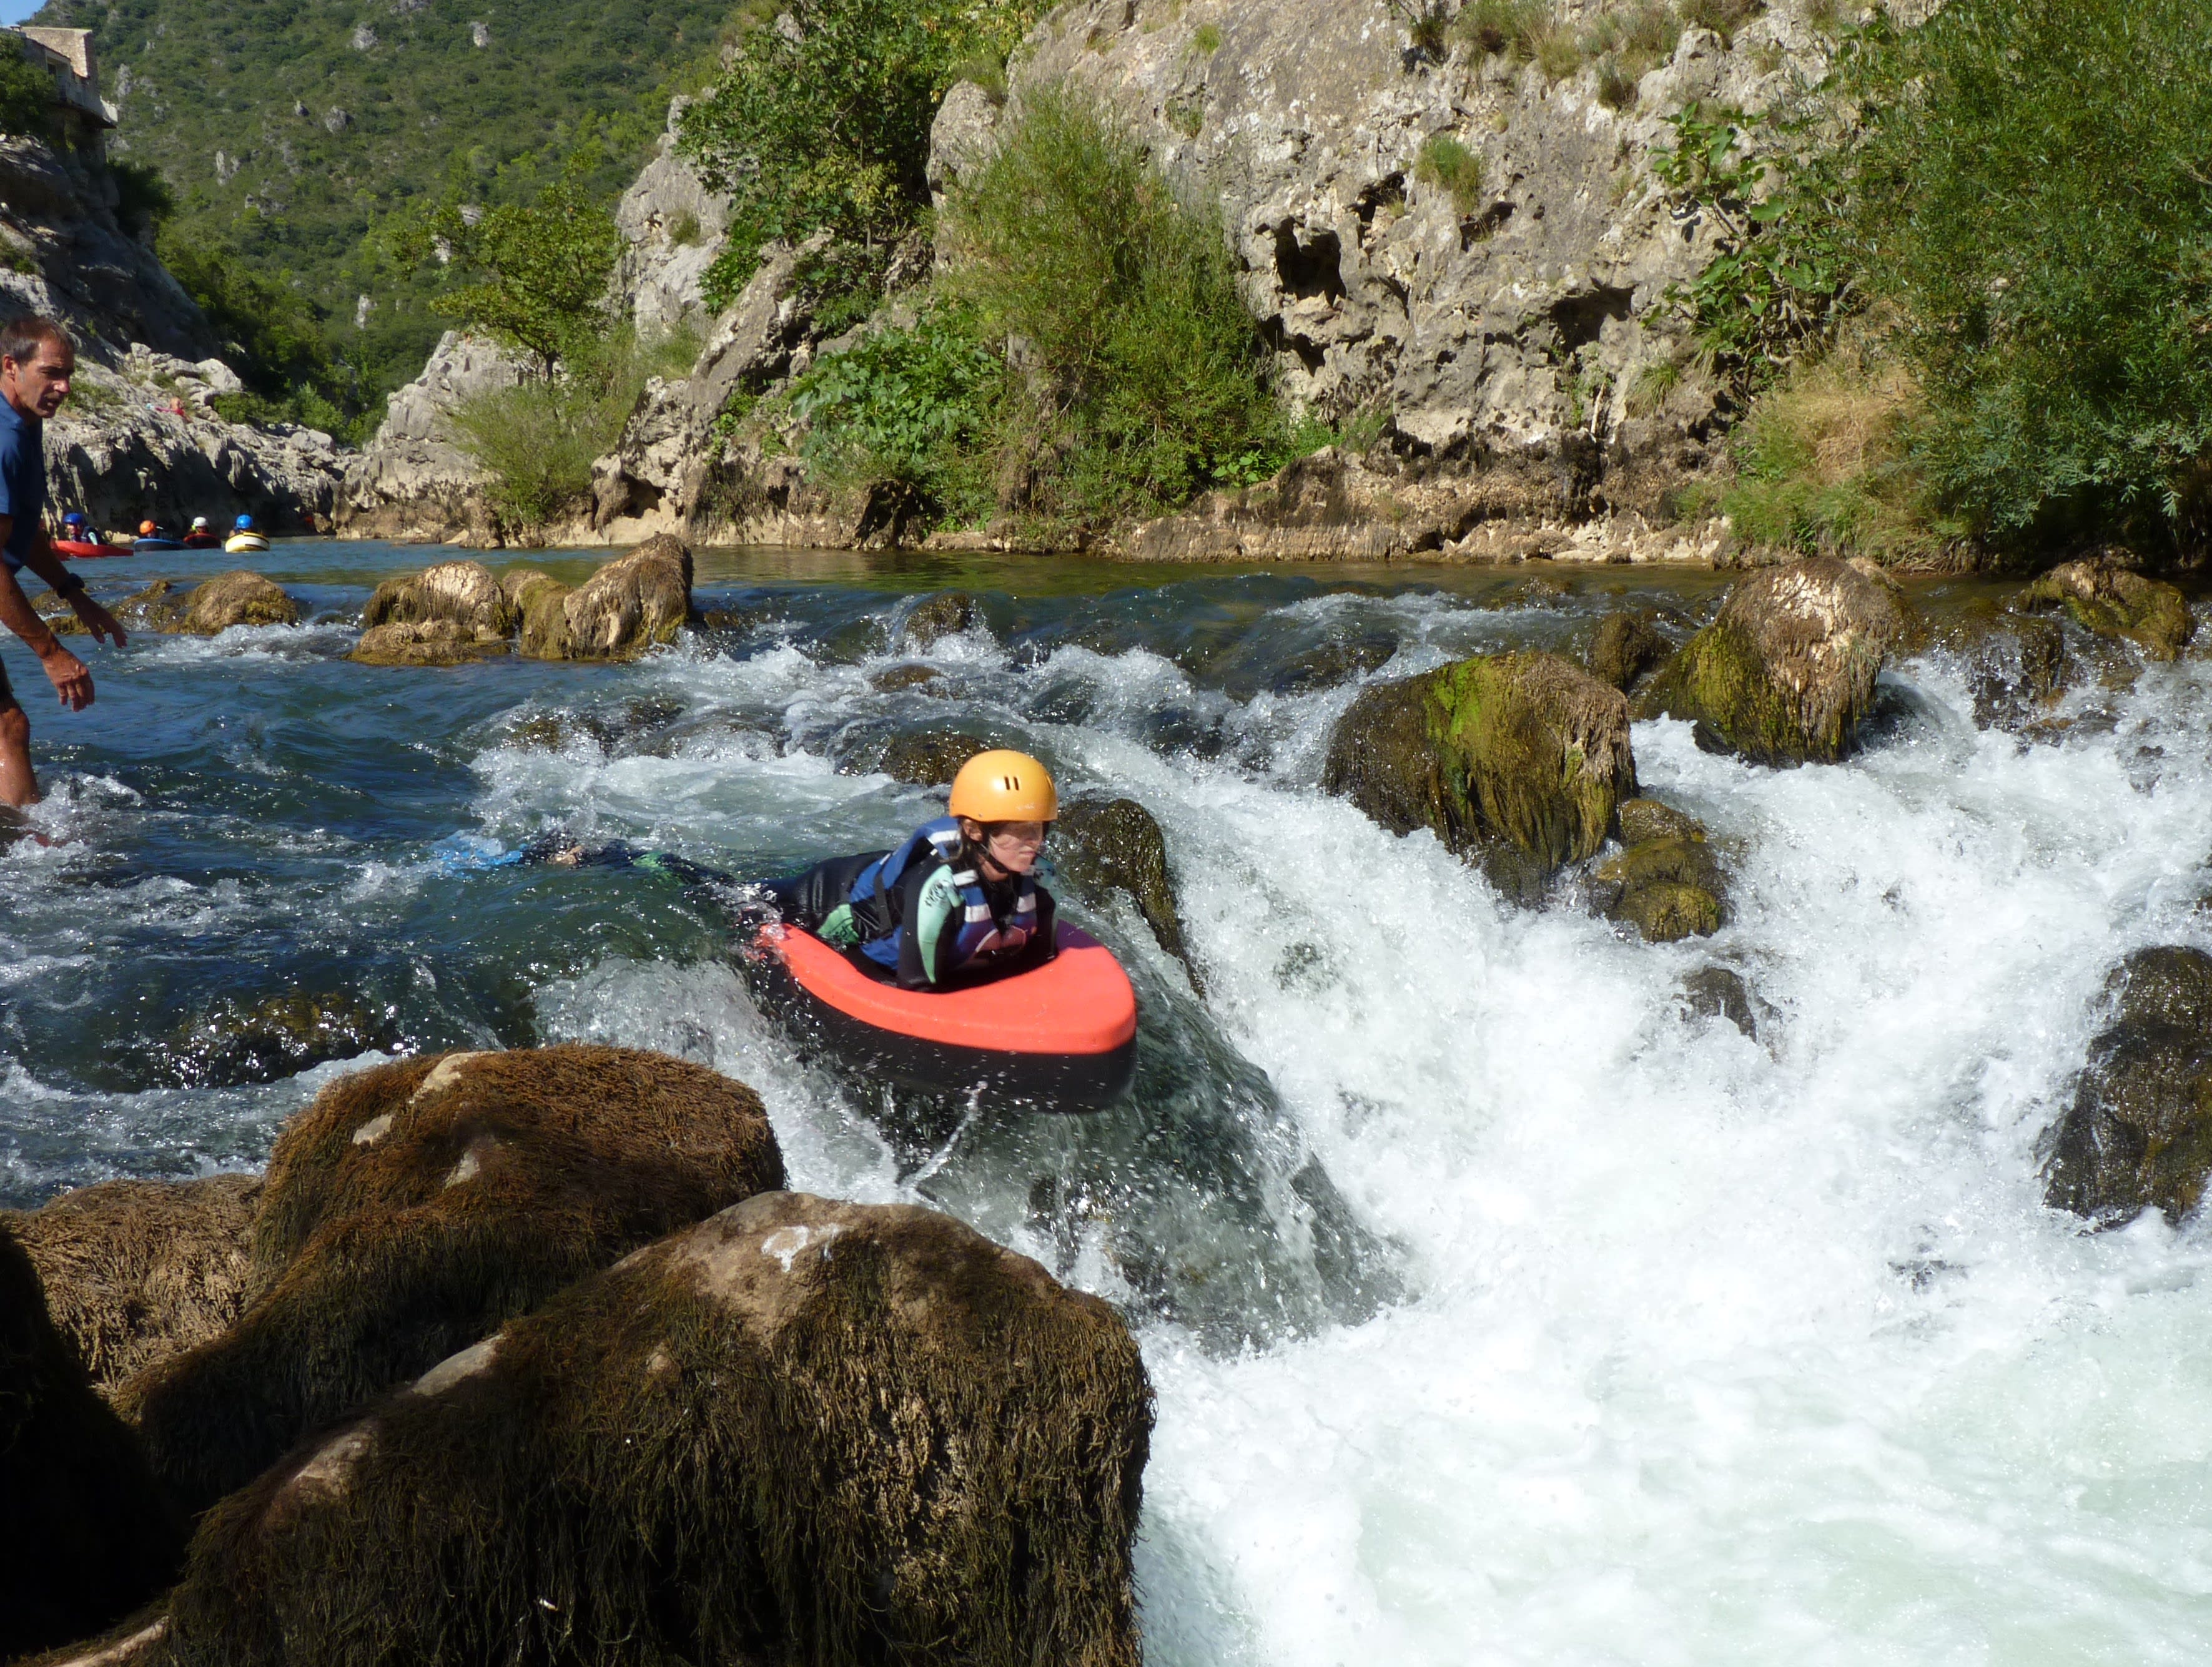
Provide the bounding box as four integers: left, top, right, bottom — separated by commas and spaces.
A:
418, 150, 621, 371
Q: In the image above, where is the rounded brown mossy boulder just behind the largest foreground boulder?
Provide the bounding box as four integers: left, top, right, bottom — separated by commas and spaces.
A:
122, 1046, 783, 1508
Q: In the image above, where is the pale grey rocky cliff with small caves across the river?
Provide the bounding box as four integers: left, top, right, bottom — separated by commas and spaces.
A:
340, 0, 1893, 559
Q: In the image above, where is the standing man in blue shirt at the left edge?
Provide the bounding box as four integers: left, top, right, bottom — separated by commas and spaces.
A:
0, 318, 124, 809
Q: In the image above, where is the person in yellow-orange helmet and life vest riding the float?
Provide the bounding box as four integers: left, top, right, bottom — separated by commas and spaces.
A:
763, 752, 1060, 990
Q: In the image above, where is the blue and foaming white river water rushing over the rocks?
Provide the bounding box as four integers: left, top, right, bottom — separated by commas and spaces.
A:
0, 544, 2212, 1667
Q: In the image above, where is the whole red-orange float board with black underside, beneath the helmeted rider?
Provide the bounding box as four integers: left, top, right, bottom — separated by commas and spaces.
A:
759, 924, 1137, 1112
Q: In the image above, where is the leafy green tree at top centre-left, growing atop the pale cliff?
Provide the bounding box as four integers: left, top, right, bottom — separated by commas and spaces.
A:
681, 0, 1042, 305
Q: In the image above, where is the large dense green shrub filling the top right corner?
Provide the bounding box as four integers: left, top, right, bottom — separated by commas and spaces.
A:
1858, 0, 2212, 546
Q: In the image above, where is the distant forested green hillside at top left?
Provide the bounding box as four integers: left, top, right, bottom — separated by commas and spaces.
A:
37, 0, 730, 435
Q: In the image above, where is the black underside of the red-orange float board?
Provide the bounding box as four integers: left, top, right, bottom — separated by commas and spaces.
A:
759, 955, 1137, 1112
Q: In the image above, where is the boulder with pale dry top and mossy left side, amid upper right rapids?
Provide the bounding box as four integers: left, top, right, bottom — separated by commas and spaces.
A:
1639, 557, 1913, 765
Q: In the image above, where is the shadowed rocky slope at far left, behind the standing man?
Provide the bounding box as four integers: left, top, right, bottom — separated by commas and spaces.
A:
0, 137, 343, 531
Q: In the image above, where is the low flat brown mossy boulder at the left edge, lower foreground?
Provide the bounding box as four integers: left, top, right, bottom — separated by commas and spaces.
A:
0, 1174, 261, 1393
